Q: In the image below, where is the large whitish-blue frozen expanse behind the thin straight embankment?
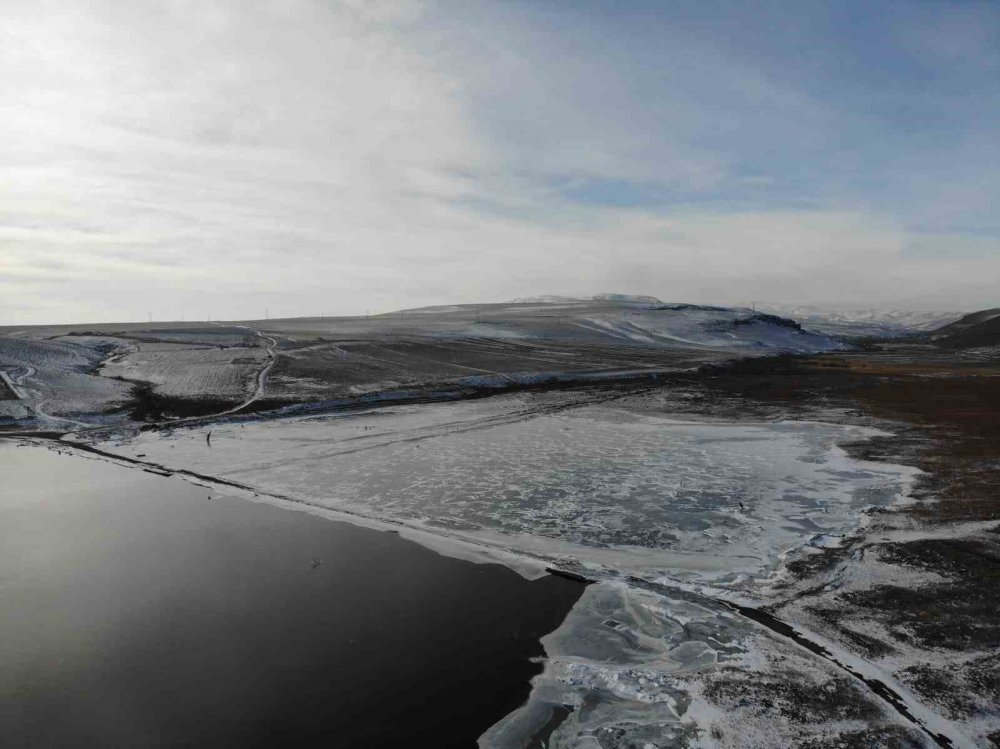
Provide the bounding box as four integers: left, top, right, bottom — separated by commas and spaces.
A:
101, 397, 911, 583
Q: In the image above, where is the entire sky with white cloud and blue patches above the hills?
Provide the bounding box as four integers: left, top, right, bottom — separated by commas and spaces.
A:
0, 0, 1000, 325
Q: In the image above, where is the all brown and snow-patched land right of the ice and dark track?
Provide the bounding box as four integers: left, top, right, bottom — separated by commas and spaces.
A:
672, 345, 1000, 747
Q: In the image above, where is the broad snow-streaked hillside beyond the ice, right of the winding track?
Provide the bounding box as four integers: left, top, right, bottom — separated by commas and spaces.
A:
247, 295, 844, 401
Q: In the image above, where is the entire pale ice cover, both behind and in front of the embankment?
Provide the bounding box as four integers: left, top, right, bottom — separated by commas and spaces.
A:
82, 391, 915, 749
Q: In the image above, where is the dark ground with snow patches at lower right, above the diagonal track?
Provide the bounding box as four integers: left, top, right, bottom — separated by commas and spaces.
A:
772, 515, 1000, 746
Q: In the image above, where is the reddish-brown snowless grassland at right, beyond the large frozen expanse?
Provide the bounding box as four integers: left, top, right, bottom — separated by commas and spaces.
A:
660, 346, 1000, 521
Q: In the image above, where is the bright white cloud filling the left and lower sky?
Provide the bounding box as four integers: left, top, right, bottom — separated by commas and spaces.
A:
0, 0, 998, 324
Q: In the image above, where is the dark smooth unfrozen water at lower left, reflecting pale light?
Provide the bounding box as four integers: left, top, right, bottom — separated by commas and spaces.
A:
0, 442, 582, 749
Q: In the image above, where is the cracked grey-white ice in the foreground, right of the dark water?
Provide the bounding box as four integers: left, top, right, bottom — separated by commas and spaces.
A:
479, 583, 749, 749
